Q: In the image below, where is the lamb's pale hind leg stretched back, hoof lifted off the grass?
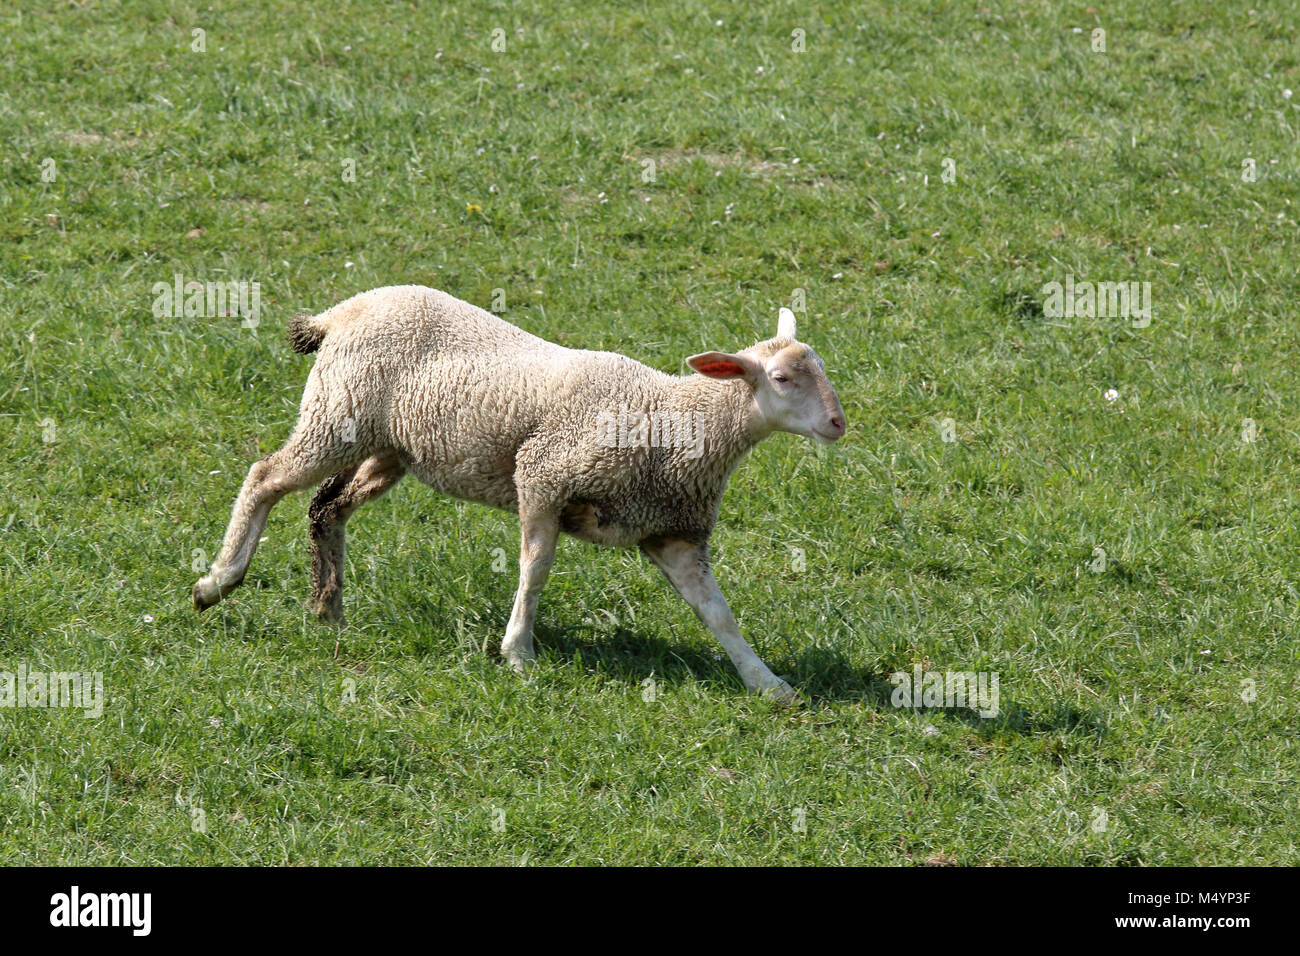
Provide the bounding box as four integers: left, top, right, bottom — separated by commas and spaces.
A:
194, 434, 358, 611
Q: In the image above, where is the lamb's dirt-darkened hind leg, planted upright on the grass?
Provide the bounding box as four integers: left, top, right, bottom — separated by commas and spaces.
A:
307, 454, 406, 623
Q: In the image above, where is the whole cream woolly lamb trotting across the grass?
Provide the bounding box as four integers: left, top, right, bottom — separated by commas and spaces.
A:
194, 286, 846, 702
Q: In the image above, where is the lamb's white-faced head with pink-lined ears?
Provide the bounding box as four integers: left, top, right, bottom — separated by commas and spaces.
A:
686, 308, 846, 445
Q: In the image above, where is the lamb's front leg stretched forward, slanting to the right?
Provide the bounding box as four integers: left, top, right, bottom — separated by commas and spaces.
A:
641, 538, 800, 704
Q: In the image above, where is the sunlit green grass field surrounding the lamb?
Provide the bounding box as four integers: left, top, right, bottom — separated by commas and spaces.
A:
0, 0, 1300, 865
